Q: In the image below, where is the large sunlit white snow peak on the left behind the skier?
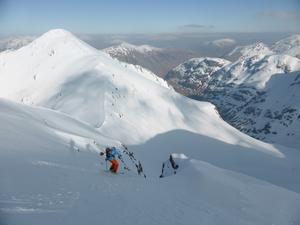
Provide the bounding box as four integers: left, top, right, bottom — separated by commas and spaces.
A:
0, 30, 270, 149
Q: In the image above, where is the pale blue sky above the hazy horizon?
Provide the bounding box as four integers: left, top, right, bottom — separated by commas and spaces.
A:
0, 0, 300, 34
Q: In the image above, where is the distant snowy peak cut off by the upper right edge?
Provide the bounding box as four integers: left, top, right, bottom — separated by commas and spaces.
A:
272, 35, 300, 58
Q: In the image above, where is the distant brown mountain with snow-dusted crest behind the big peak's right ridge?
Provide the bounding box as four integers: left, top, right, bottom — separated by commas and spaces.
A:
103, 43, 196, 77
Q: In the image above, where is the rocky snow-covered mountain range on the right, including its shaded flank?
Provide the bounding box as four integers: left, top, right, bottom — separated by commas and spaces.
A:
166, 35, 300, 148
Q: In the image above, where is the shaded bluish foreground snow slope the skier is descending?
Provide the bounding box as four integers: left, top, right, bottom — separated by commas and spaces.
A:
0, 100, 300, 225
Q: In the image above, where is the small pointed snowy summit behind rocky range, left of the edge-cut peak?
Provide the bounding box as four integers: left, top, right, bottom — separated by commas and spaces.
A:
226, 42, 273, 61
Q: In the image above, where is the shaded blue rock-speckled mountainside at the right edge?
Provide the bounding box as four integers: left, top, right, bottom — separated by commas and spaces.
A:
230, 71, 300, 148
